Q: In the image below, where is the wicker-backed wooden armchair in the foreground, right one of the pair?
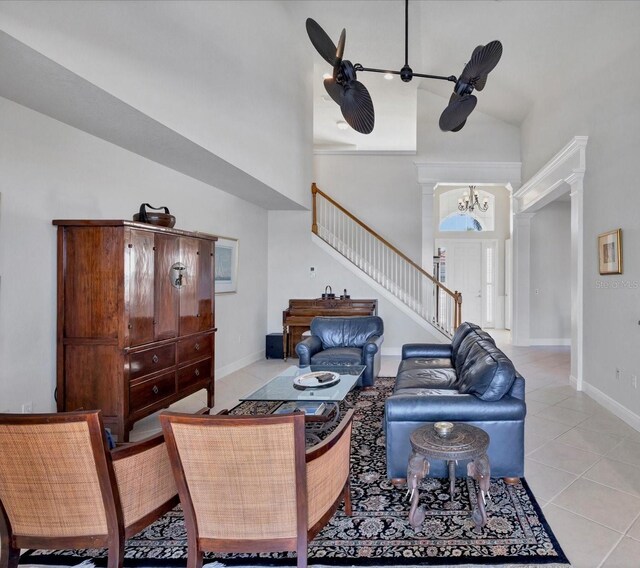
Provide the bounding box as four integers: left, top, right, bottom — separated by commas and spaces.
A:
160, 410, 353, 568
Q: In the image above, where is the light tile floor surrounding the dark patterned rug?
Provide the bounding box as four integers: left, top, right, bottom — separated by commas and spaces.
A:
132, 331, 640, 568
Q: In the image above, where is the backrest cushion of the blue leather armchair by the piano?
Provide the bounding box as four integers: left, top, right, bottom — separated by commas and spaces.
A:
311, 316, 384, 349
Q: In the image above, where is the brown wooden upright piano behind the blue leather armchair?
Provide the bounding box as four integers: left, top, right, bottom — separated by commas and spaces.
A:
282, 298, 378, 359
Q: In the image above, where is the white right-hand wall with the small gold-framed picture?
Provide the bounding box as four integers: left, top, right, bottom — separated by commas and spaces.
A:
522, 38, 640, 417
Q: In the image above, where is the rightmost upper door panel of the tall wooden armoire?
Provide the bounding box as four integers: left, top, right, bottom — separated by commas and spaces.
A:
180, 237, 213, 335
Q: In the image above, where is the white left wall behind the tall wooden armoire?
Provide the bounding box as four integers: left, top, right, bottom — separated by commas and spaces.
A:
0, 98, 267, 412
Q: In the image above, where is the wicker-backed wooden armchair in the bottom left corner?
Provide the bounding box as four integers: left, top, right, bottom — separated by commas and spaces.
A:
0, 411, 178, 568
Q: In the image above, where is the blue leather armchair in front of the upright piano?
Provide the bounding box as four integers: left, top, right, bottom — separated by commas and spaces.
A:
296, 316, 384, 387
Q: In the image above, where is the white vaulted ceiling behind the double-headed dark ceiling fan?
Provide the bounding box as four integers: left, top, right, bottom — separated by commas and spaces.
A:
289, 0, 640, 151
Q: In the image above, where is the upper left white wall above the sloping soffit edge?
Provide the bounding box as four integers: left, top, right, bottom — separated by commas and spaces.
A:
0, 0, 313, 209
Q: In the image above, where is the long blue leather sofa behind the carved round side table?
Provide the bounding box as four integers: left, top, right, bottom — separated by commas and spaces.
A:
384, 322, 526, 481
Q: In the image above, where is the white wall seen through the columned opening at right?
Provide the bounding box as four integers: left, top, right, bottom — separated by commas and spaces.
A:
529, 201, 571, 345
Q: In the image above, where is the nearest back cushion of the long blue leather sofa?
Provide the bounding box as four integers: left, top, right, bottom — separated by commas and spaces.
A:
456, 339, 516, 401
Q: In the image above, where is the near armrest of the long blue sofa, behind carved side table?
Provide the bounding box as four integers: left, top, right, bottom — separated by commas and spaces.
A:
385, 394, 527, 423
